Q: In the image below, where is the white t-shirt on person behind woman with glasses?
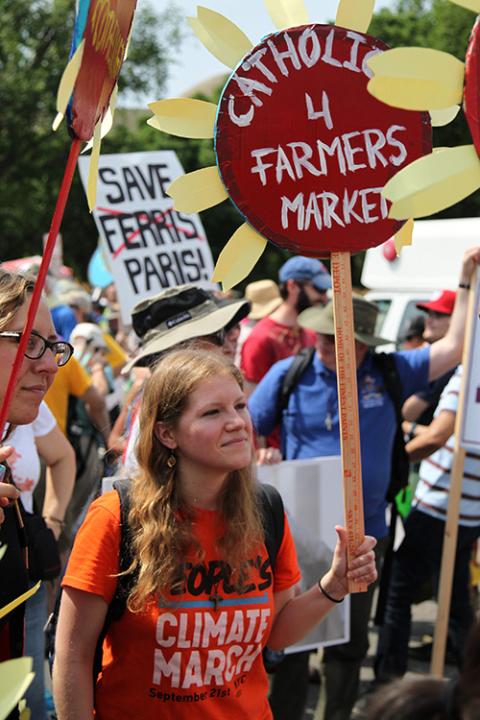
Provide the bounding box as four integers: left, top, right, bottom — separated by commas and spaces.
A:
8, 402, 57, 512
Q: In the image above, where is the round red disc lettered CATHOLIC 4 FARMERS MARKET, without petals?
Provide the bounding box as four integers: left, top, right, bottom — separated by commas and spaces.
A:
216, 25, 431, 257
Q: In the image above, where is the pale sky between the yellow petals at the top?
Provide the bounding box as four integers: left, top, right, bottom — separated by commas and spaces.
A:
163, 0, 394, 97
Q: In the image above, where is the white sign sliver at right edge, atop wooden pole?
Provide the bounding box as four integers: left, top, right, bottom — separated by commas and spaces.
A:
460, 275, 480, 449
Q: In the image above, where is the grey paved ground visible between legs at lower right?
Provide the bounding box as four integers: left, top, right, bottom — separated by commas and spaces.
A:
304, 601, 456, 720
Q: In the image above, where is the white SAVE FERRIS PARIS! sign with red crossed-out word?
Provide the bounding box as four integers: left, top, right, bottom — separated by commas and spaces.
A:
78, 150, 213, 324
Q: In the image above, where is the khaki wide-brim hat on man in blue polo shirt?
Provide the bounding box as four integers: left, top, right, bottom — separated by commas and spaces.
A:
298, 295, 392, 347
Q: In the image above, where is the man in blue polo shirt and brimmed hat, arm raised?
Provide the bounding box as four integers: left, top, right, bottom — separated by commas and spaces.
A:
249, 248, 480, 720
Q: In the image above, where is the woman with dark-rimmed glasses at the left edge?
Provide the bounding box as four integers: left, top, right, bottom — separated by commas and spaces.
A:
0, 271, 73, 717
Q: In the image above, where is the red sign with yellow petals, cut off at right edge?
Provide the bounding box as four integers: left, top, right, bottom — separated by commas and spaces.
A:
368, 0, 480, 220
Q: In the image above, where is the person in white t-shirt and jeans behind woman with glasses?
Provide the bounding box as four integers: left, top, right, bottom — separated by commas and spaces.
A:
8, 402, 75, 720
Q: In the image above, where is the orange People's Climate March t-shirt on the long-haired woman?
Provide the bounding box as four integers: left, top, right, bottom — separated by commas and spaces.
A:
62, 491, 300, 720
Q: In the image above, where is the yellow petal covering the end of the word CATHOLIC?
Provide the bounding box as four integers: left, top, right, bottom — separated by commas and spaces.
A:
367, 48, 465, 110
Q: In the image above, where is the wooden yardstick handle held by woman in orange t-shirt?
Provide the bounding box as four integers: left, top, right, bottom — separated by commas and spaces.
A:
331, 252, 367, 592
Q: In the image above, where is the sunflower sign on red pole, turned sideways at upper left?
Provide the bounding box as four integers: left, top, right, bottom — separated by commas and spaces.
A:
0, 0, 136, 436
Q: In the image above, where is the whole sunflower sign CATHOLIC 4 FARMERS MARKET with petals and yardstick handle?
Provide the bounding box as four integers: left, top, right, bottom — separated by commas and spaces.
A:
149, 0, 431, 592
